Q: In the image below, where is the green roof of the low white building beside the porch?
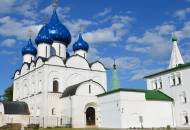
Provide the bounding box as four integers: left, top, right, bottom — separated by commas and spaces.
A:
97, 88, 173, 101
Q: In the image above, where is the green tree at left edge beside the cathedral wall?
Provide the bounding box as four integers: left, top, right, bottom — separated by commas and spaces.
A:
3, 85, 13, 101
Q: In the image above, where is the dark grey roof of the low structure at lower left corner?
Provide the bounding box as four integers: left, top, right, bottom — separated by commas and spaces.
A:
1, 101, 30, 115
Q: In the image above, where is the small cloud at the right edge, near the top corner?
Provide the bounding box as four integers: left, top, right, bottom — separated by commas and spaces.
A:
174, 8, 190, 19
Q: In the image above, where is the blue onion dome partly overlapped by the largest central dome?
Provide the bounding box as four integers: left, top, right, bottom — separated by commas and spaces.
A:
35, 24, 53, 45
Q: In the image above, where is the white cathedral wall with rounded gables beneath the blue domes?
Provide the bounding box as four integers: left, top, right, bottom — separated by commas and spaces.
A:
13, 56, 107, 126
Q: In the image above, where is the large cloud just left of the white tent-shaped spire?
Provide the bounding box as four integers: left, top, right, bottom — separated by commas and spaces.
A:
126, 24, 175, 59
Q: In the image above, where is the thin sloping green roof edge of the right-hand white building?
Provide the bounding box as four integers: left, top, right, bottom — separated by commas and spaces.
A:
144, 62, 190, 78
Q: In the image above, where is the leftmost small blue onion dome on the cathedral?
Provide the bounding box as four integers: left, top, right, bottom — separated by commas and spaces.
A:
22, 39, 37, 56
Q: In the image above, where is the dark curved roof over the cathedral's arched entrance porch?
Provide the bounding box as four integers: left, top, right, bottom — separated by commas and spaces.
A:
61, 79, 105, 98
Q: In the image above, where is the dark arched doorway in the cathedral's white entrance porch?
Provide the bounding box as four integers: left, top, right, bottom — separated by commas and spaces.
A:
86, 107, 95, 125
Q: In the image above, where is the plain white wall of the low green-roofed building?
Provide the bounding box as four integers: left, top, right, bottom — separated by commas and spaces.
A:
98, 92, 174, 128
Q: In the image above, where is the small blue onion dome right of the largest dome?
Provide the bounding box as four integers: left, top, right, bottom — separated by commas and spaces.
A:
73, 33, 89, 51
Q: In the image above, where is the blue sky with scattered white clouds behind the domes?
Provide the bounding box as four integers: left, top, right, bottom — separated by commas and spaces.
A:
0, 0, 190, 94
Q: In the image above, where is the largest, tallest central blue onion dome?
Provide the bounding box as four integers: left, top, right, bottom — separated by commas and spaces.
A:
48, 9, 71, 46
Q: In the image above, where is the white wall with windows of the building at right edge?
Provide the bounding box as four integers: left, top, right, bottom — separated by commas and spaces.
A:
147, 68, 190, 128
